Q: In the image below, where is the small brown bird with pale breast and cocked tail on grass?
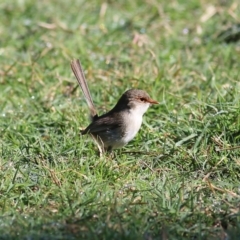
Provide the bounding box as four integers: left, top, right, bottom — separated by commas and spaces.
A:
71, 60, 158, 154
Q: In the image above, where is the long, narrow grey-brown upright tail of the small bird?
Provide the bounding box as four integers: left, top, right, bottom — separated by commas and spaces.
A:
71, 59, 97, 120
